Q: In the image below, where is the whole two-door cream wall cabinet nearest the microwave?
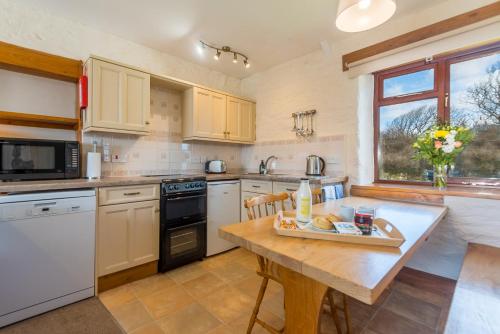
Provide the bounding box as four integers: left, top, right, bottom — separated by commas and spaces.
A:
83, 58, 150, 135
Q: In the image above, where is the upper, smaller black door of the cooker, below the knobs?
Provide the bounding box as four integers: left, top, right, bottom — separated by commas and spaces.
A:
161, 191, 207, 227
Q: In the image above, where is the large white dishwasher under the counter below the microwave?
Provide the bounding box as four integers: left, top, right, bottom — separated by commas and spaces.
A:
0, 190, 96, 327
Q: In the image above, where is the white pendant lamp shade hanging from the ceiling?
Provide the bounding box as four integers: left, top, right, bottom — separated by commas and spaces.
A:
335, 0, 396, 32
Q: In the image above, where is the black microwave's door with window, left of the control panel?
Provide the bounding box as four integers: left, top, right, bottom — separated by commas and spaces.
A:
0, 139, 66, 180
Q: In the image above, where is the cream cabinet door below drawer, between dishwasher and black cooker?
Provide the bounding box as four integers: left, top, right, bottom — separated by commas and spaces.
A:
97, 200, 160, 276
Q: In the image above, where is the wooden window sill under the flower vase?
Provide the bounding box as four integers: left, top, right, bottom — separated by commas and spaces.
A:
351, 183, 500, 204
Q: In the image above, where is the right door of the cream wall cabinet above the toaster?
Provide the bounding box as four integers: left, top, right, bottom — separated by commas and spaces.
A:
227, 96, 255, 142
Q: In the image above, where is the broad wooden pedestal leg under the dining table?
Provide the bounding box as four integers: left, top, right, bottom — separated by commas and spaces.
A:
278, 266, 328, 334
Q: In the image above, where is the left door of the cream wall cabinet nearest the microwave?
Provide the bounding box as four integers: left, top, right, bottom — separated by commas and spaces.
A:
90, 59, 124, 129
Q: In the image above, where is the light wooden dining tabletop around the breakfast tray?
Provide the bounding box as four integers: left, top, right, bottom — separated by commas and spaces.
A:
219, 197, 447, 304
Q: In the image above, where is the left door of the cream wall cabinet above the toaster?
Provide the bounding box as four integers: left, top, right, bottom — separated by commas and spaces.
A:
193, 88, 226, 139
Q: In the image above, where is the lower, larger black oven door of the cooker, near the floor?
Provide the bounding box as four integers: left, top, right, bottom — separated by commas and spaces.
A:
158, 220, 207, 272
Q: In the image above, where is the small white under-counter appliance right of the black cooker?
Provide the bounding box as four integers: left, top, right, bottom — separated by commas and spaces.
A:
207, 180, 240, 256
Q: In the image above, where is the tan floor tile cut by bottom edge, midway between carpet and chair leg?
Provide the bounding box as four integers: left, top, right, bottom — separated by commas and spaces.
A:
158, 303, 221, 334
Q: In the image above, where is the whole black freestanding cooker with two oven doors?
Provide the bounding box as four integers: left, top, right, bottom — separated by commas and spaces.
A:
158, 176, 207, 272
